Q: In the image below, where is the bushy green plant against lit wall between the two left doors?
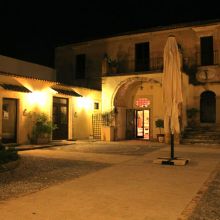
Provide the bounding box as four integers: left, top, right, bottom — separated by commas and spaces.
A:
31, 113, 57, 144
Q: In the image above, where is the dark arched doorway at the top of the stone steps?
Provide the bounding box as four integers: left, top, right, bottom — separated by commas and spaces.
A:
200, 91, 216, 123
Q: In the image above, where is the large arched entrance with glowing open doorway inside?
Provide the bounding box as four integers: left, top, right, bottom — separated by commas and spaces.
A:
113, 76, 161, 140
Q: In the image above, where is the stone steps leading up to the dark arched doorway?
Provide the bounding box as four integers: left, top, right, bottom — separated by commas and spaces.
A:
181, 125, 220, 145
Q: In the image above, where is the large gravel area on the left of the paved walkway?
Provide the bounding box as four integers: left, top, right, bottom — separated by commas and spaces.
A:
0, 156, 110, 201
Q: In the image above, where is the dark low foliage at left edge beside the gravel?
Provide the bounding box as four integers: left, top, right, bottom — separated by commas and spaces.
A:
0, 145, 19, 164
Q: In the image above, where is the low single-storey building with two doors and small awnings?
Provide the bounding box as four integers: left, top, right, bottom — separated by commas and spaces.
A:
0, 56, 101, 144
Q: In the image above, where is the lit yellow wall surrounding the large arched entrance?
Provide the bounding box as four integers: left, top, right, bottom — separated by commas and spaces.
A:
102, 74, 163, 139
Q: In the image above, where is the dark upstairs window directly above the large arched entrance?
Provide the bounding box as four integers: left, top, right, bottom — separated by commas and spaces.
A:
135, 42, 150, 72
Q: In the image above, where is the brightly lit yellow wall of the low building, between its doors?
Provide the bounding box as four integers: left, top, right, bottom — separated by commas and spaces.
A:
0, 76, 101, 144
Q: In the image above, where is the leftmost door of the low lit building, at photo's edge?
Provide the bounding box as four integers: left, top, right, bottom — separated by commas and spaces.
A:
2, 98, 17, 143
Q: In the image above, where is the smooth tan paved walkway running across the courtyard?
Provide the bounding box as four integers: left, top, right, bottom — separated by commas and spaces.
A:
0, 142, 220, 220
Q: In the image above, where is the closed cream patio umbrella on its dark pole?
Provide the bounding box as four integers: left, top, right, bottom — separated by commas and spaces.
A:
163, 36, 183, 159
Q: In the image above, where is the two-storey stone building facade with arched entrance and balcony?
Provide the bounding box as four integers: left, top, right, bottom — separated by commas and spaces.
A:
56, 20, 220, 140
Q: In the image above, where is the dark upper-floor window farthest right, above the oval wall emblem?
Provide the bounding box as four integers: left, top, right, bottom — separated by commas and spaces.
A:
200, 36, 214, 66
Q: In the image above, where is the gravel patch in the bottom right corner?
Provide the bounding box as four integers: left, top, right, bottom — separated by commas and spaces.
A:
189, 166, 220, 220
